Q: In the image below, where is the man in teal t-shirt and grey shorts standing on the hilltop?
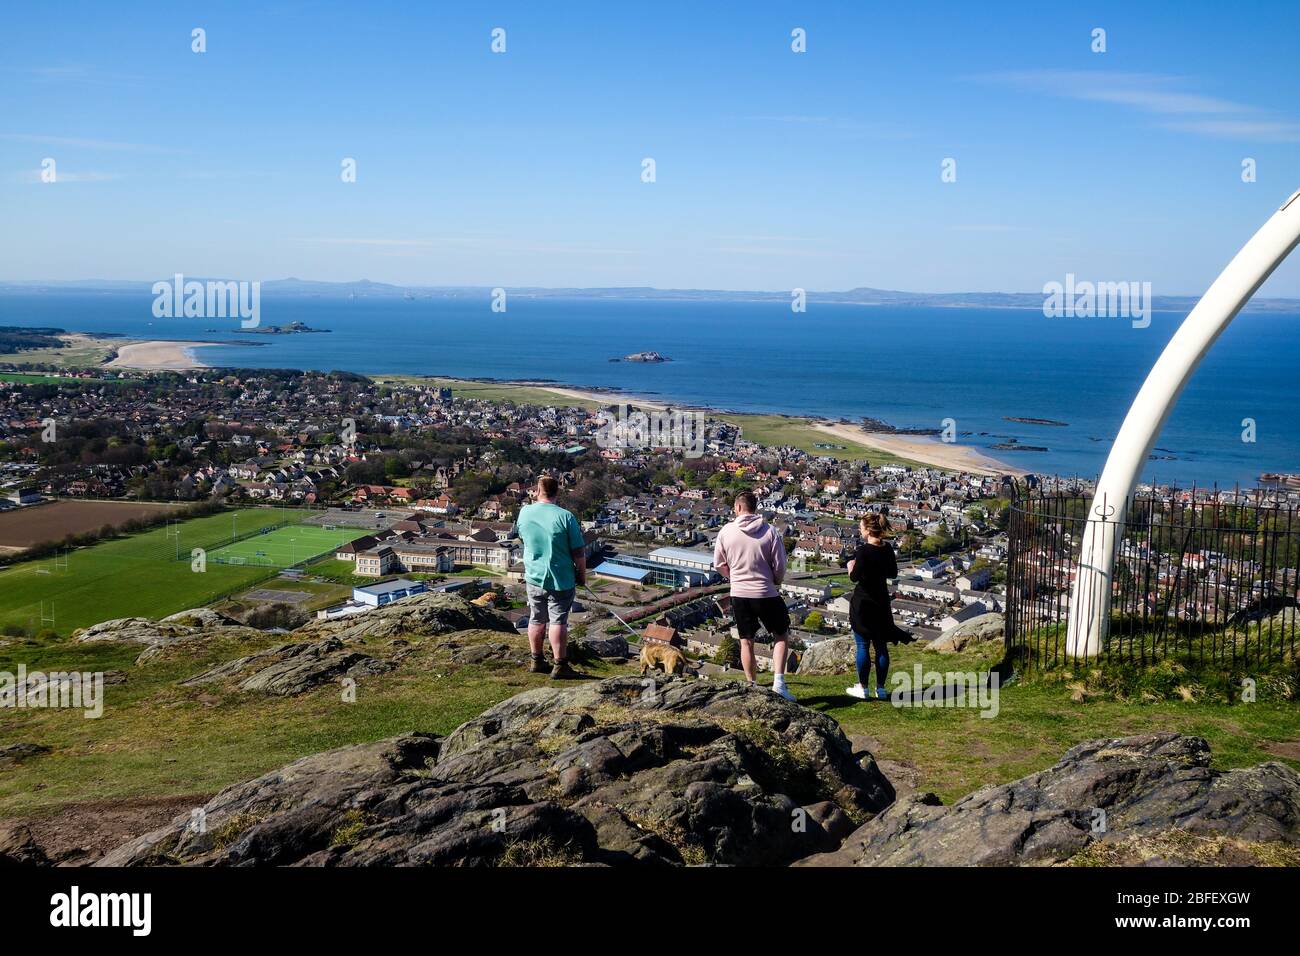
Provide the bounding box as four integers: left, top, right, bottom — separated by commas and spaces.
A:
515, 475, 586, 679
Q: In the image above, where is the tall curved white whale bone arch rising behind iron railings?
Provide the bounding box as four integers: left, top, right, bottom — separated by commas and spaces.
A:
1066, 190, 1300, 657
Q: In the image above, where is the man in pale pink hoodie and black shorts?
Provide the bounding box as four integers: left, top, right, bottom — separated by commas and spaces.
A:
714, 492, 794, 700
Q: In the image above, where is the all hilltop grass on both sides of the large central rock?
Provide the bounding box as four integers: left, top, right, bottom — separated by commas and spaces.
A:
0, 621, 1300, 818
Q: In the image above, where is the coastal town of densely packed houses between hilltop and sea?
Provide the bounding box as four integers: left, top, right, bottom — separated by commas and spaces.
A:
0, 358, 1300, 663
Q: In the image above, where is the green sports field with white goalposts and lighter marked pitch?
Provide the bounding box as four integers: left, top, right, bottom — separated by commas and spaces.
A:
0, 509, 364, 635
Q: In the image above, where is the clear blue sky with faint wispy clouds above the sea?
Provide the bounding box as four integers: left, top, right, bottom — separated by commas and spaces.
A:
0, 1, 1300, 295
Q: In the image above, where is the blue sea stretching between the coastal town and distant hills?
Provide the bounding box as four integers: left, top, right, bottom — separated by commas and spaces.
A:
0, 291, 1300, 485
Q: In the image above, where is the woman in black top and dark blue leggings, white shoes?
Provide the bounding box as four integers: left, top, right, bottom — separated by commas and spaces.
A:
845, 514, 911, 700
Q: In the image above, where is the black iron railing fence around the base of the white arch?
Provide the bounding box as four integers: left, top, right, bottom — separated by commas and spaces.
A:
1006, 492, 1300, 667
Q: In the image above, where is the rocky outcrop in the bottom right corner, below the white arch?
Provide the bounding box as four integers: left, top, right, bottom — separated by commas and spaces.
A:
802, 734, 1300, 866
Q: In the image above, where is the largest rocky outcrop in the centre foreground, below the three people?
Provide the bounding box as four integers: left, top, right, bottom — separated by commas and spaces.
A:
100, 678, 893, 866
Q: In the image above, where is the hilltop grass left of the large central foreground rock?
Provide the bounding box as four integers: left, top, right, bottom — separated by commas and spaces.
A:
0, 632, 629, 818
